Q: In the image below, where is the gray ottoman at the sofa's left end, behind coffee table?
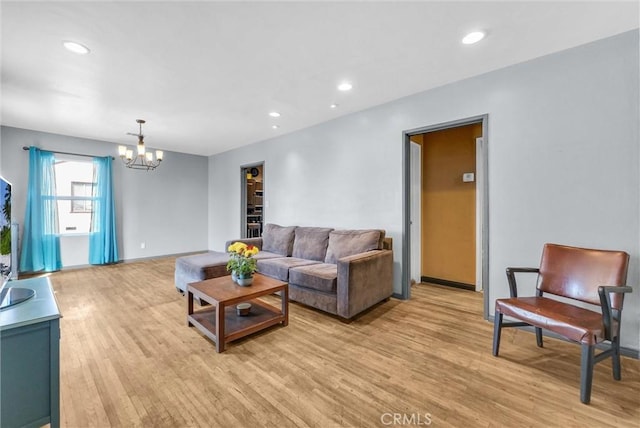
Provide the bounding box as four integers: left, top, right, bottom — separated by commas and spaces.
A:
175, 251, 229, 293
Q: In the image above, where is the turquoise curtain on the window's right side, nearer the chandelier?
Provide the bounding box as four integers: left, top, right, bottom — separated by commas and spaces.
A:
89, 156, 119, 265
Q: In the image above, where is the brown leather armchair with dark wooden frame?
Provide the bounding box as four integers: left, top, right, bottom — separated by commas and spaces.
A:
493, 244, 632, 404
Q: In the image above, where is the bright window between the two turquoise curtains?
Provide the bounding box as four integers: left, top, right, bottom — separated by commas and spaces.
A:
55, 160, 94, 235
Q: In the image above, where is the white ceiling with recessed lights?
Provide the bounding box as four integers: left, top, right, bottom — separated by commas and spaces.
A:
0, 1, 639, 155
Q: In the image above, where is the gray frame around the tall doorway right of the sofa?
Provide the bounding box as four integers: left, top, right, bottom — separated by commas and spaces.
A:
400, 114, 489, 318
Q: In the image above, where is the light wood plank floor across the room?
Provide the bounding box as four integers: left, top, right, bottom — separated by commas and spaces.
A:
51, 258, 640, 428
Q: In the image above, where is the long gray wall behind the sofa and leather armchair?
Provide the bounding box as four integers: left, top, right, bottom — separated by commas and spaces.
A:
209, 31, 640, 350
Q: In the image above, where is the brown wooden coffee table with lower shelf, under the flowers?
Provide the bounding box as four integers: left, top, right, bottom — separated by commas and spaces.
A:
186, 274, 289, 352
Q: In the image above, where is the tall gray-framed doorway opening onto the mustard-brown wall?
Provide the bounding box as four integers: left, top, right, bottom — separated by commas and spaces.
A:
402, 115, 488, 315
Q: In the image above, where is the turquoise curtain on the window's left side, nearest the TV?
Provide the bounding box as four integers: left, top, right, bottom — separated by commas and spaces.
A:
20, 146, 62, 272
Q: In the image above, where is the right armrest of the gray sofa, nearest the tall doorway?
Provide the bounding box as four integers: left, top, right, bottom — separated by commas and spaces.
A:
337, 250, 393, 318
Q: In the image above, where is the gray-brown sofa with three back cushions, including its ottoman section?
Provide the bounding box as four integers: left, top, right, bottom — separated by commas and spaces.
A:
176, 224, 393, 319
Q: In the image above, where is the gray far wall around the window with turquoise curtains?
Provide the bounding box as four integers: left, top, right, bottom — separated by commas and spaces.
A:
0, 126, 208, 267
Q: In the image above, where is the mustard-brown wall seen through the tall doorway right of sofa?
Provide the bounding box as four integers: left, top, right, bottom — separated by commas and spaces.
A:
422, 123, 482, 289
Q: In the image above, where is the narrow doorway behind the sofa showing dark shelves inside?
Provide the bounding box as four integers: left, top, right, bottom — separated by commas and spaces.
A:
240, 163, 265, 238
